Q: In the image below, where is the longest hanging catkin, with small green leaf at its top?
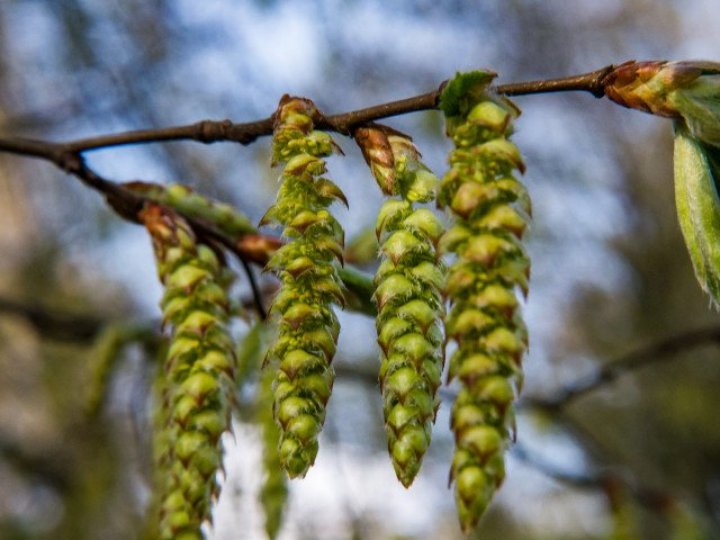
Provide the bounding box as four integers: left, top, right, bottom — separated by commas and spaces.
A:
438, 72, 530, 532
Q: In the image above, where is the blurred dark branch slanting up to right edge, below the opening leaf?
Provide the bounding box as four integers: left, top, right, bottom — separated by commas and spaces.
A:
521, 327, 720, 412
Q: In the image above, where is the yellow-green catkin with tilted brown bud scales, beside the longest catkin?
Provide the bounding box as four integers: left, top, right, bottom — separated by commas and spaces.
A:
355, 125, 444, 487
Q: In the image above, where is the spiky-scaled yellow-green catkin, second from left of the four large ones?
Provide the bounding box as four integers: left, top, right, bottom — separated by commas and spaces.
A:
262, 96, 345, 478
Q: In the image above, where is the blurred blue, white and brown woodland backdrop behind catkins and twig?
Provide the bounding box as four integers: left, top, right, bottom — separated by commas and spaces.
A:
0, 0, 720, 540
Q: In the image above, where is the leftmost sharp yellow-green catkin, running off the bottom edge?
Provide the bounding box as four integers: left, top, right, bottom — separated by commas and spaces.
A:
141, 205, 235, 539
